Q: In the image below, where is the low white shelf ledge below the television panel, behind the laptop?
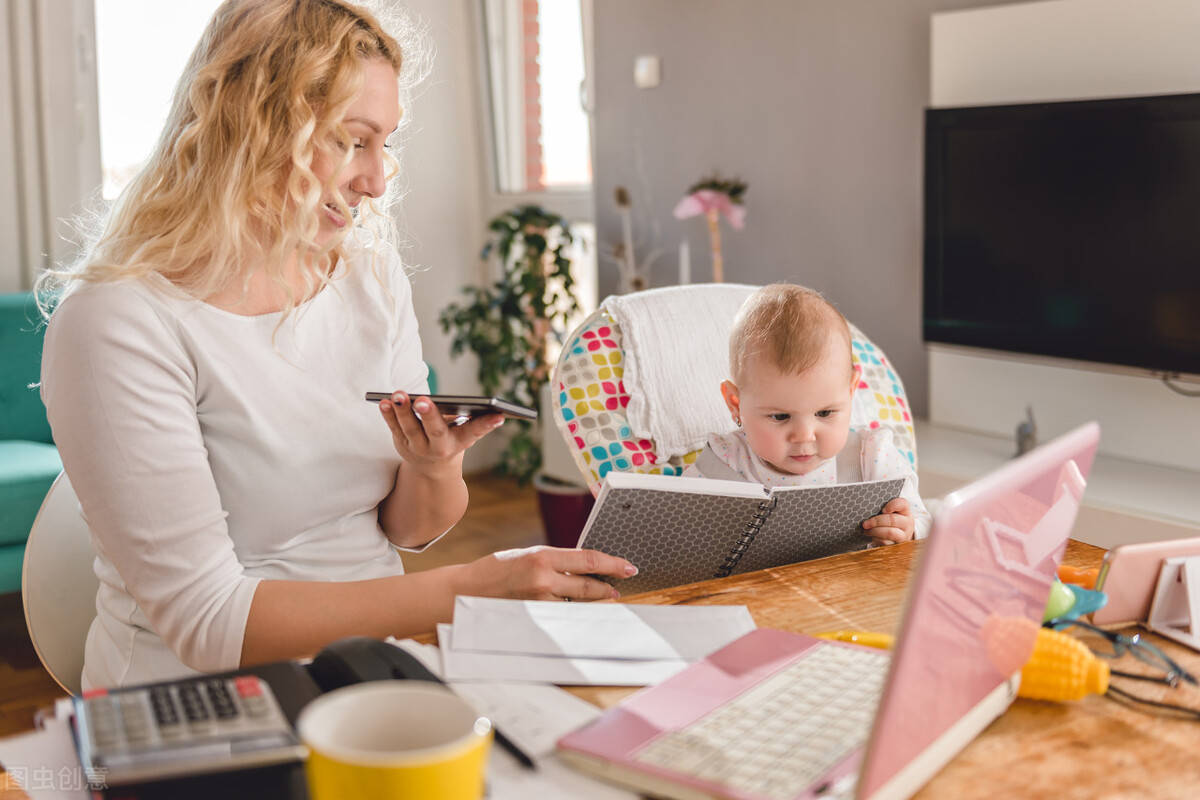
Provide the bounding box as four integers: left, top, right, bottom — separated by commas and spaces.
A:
916, 420, 1200, 547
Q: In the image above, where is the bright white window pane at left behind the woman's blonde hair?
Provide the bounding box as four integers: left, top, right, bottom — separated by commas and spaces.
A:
95, 0, 221, 200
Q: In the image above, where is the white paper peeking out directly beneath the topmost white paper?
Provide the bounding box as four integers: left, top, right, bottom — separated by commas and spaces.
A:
438, 625, 691, 686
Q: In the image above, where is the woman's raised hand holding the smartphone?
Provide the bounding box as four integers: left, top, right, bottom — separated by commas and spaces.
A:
379, 392, 504, 473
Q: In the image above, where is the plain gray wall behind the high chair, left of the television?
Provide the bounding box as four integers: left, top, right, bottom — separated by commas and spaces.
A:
594, 0, 1032, 415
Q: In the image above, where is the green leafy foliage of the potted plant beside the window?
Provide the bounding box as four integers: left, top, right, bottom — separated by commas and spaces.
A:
438, 205, 590, 484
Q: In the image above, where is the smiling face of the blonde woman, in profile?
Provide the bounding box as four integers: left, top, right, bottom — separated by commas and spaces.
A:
312, 59, 400, 245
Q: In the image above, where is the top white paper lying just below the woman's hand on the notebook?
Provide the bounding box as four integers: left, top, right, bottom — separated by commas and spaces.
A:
443, 596, 755, 662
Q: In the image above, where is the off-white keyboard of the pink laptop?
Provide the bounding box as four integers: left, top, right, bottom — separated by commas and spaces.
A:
634, 645, 890, 799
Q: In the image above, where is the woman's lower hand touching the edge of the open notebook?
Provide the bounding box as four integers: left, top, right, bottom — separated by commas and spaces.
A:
457, 546, 637, 600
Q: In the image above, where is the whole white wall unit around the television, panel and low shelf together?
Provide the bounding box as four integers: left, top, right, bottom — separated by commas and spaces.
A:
917, 0, 1200, 547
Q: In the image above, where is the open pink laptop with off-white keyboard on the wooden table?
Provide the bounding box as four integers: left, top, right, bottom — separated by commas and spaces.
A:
558, 422, 1099, 800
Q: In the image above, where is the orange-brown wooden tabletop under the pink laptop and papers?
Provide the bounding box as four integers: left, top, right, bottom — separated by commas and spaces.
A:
571, 541, 1200, 800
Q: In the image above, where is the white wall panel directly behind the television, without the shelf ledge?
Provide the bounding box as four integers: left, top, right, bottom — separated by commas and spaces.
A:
929, 0, 1200, 470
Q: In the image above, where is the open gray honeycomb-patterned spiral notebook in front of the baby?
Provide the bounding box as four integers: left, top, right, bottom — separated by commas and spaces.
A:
578, 473, 904, 595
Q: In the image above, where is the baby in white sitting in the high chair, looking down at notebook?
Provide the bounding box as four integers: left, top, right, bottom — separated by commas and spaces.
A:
684, 283, 931, 543
